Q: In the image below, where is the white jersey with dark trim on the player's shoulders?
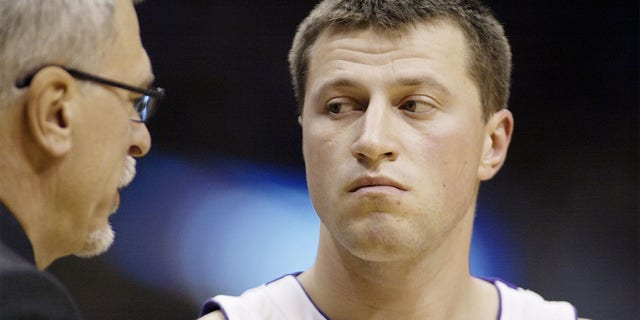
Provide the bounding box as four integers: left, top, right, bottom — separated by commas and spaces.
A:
201, 275, 577, 320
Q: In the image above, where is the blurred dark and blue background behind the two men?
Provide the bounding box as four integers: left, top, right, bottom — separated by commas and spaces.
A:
50, 0, 640, 319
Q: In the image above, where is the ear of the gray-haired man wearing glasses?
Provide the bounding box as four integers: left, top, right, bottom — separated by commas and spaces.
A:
26, 66, 76, 157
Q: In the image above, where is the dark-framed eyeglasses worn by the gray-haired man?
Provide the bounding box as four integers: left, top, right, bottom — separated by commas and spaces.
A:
16, 66, 165, 123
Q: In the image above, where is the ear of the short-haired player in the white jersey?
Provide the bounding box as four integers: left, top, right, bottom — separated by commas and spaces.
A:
478, 109, 513, 181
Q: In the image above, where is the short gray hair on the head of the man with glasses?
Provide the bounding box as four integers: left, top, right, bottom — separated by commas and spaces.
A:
0, 0, 120, 111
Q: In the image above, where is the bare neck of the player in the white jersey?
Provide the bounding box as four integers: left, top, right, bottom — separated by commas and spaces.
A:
299, 214, 499, 320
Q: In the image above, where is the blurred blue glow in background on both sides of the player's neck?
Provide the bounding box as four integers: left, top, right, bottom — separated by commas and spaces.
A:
106, 152, 517, 303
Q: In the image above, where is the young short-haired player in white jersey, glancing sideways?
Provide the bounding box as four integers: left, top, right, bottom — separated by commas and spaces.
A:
203, 0, 576, 320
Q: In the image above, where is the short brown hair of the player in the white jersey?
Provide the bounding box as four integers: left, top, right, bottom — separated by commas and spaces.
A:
289, 0, 511, 120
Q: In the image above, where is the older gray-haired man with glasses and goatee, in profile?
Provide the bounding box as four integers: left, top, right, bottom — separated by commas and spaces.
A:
0, 0, 164, 319
